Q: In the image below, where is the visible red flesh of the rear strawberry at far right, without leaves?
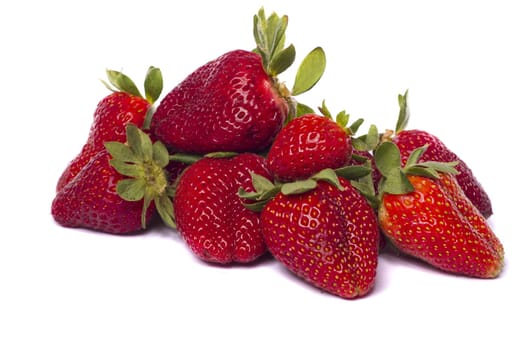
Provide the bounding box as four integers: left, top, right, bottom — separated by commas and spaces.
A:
392, 130, 492, 217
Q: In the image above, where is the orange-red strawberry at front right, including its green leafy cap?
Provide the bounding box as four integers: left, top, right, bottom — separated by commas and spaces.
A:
376, 142, 504, 278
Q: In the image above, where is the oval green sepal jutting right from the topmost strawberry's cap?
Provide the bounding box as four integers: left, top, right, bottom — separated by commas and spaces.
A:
292, 47, 326, 96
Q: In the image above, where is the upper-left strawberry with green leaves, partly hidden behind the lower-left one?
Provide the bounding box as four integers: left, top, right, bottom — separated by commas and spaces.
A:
56, 67, 162, 192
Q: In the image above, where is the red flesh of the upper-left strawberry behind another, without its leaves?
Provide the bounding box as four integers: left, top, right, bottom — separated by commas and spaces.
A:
56, 92, 150, 192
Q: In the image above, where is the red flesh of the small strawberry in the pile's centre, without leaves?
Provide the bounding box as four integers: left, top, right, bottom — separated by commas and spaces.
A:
268, 114, 352, 181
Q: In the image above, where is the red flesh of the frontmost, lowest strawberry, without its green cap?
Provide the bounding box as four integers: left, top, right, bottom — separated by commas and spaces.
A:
261, 178, 379, 299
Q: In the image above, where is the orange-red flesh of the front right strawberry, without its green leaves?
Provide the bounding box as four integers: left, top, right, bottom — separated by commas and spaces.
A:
378, 175, 503, 278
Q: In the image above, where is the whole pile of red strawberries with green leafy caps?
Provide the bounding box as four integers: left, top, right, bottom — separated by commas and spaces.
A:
51, 9, 504, 299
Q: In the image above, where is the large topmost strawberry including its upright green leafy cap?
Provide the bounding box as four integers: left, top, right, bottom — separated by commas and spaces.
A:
151, 9, 325, 154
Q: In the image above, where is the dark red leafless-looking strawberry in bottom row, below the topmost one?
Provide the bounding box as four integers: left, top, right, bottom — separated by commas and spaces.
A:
173, 153, 270, 264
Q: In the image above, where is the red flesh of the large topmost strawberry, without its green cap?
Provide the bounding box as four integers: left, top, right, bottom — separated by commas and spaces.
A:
151, 50, 288, 154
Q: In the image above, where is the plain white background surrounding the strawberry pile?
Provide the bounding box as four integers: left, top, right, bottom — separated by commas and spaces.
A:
0, 0, 525, 349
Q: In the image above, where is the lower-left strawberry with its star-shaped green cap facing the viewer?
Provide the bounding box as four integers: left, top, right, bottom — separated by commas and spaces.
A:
51, 124, 173, 234
